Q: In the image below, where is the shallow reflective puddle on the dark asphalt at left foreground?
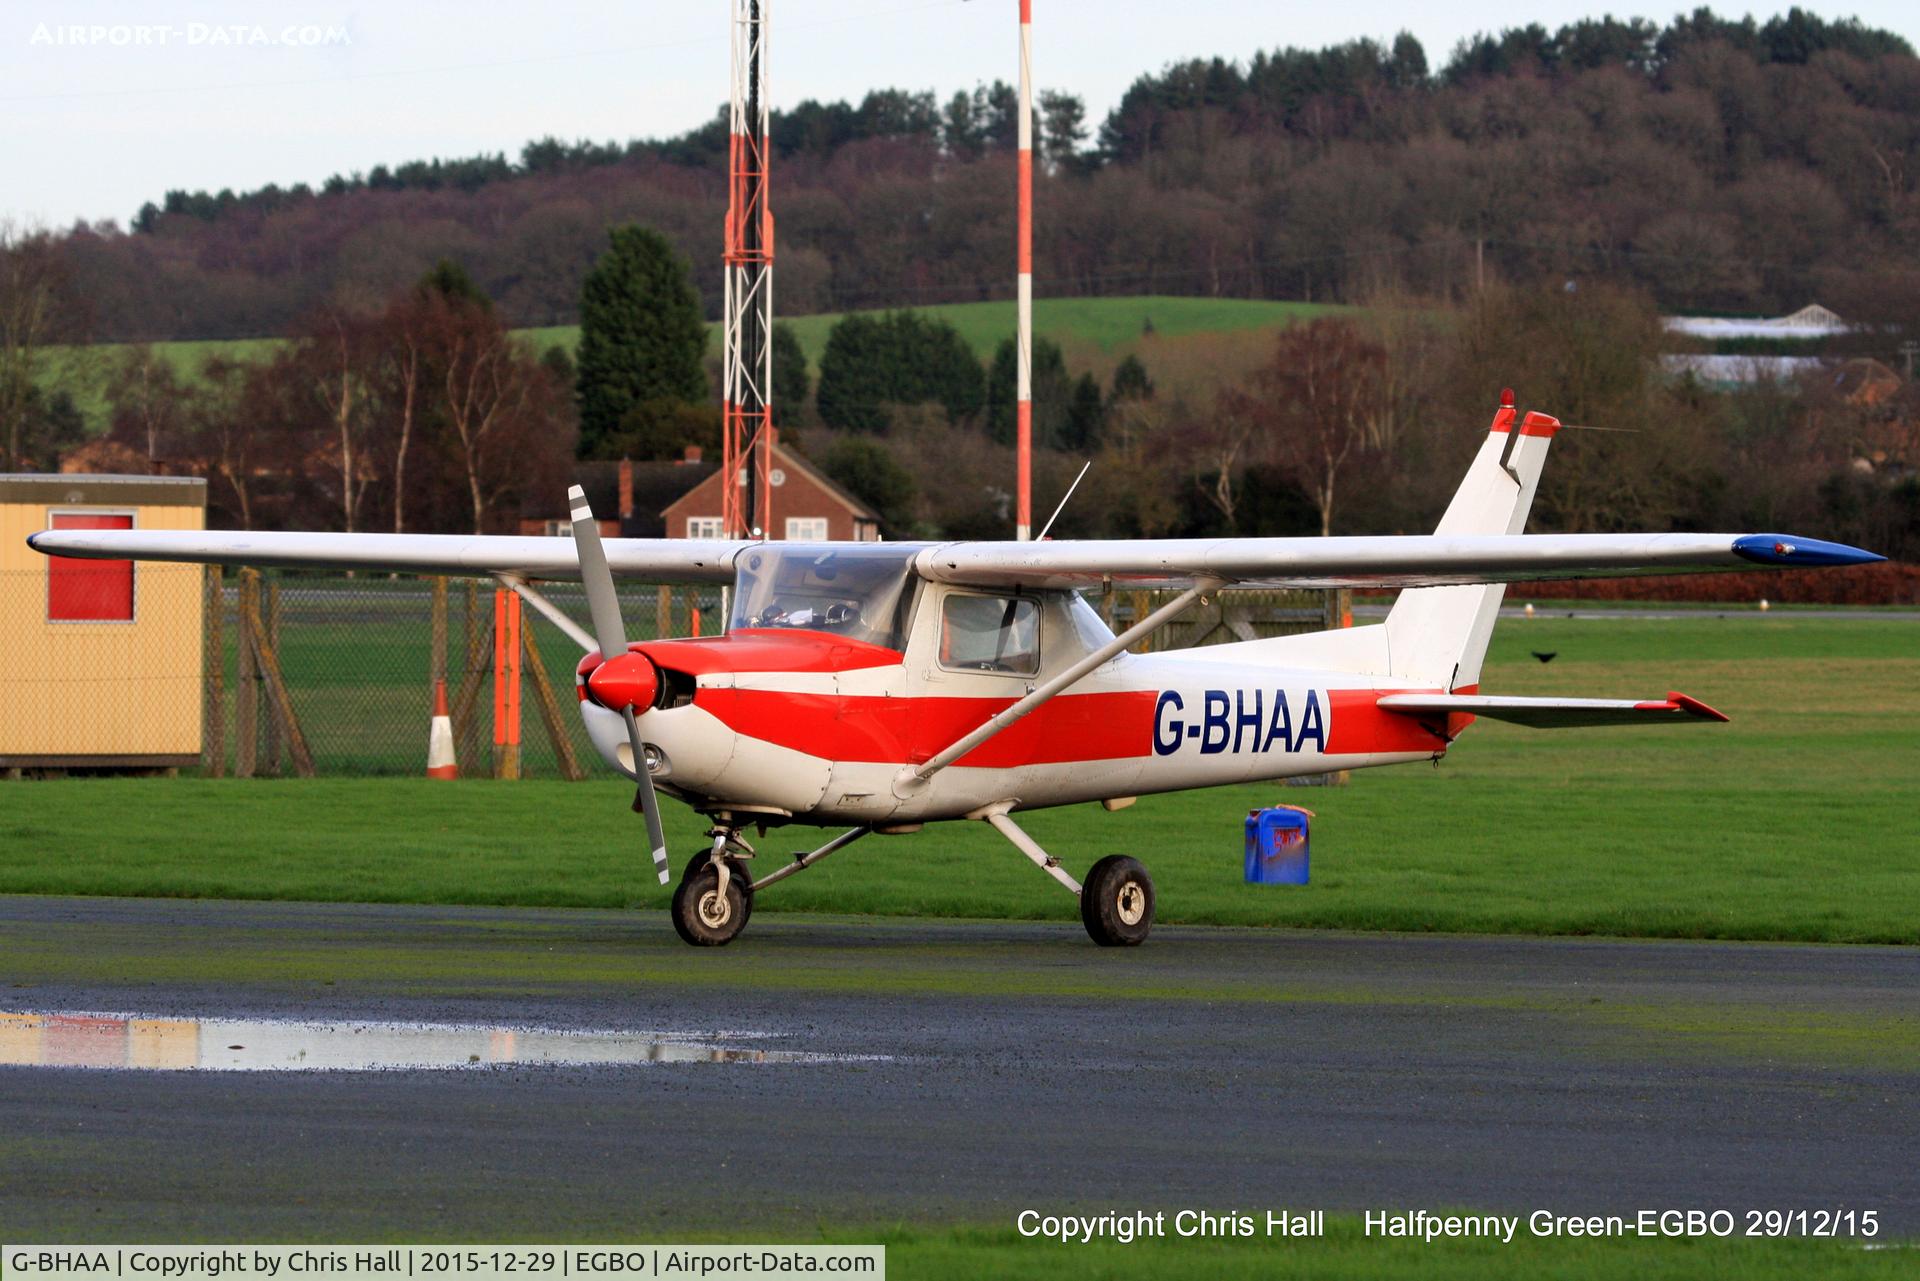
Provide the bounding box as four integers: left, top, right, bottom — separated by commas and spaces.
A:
0, 1012, 885, 1072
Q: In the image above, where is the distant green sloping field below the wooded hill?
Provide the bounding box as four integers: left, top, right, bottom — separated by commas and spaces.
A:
52, 296, 1346, 430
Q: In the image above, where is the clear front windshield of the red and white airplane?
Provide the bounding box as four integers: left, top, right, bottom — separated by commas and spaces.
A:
732, 544, 920, 649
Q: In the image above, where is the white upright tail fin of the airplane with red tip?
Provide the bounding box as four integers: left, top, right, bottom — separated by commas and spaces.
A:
1386, 392, 1559, 691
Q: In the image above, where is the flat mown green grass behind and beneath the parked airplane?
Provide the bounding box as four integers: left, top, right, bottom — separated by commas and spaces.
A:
0, 615, 1920, 943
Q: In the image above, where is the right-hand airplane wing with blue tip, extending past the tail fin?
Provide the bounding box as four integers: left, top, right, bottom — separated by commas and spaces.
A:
916, 534, 1885, 588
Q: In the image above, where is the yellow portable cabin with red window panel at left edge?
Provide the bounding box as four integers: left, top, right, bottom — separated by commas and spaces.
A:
0, 474, 207, 772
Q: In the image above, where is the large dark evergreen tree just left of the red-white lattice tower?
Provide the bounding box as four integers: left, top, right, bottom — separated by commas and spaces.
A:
576, 223, 708, 455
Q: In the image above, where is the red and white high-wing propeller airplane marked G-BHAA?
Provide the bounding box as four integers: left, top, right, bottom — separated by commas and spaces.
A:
29, 392, 1884, 945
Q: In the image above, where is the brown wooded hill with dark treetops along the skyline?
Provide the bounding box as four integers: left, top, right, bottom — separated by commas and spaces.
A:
22, 10, 1920, 340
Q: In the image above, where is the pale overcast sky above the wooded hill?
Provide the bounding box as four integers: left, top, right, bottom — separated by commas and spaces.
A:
0, 0, 1920, 225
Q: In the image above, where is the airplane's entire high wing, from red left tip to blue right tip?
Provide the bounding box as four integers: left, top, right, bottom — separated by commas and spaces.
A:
27, 530, 1885, 590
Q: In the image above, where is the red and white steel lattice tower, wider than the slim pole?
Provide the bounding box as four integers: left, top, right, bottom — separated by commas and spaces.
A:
720, 0, 774, 538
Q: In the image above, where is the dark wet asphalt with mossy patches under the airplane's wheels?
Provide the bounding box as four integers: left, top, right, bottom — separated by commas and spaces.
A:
0, 897, 1920, 1241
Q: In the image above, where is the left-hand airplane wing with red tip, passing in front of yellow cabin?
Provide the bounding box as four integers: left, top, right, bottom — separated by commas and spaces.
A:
27, 530, 747, 584
